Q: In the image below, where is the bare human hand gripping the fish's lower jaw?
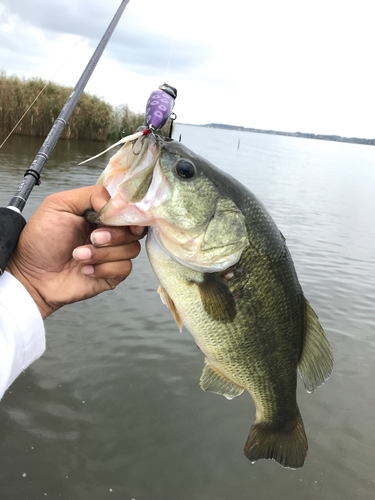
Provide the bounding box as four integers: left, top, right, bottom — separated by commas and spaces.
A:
7, 186, 144, 319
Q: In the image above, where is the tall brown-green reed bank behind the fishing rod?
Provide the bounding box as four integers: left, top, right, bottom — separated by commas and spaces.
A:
0, 71, 169, 141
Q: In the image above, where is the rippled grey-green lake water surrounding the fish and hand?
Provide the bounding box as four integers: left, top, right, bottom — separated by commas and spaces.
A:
0, 125, 375, 500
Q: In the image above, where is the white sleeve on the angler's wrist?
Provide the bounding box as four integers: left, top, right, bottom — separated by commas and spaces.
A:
0, 272, 46, 399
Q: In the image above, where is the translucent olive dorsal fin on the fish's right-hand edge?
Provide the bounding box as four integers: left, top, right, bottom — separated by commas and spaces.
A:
298, 299, 333, 392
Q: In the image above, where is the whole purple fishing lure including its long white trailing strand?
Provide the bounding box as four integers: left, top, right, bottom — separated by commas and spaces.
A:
79, 83, 177, 165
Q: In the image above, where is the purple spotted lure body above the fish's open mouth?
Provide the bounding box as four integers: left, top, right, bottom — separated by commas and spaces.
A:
146, 83, 177, 130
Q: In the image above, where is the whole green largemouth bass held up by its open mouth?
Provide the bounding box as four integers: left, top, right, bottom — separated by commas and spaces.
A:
85, 133, 333, 469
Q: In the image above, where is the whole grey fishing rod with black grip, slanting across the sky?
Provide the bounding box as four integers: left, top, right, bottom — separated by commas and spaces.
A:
0, 0, 129, 275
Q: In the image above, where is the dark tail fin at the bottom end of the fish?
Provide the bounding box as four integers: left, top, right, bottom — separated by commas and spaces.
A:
244, 412, 307, 469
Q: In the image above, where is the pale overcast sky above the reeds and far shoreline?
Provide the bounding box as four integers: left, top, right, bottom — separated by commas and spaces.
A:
0, 0, 375, 138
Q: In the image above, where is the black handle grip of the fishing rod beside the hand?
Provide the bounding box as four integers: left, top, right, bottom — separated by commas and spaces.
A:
0, 207, 26, 275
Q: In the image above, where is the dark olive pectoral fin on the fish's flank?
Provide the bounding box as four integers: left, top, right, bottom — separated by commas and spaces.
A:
194, 273, 237, 323
